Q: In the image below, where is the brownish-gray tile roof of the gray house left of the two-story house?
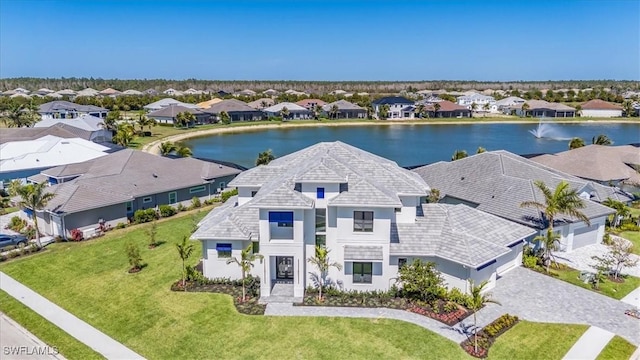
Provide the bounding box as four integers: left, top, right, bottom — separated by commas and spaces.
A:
41, 149, 240, 213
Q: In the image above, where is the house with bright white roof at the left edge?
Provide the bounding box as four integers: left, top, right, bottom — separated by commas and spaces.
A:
0, 135, 110, 183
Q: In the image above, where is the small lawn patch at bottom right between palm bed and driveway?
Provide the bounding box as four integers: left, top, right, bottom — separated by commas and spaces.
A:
489, 321, 589, 360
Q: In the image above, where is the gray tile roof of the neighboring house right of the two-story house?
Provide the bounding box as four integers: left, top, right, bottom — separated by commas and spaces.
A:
413, 151, 627, 227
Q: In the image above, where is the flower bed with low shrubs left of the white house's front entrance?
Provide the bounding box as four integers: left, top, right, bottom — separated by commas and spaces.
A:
171, 278, 266, 315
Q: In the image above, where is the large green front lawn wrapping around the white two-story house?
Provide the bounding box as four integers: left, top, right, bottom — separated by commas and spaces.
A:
0, 212, 469, 359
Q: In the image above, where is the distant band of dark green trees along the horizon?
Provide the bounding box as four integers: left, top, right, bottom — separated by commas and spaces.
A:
0, 77, 640, 94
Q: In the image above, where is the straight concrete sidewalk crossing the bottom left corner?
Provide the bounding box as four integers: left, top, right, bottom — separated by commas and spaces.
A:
0, 272, 144, 360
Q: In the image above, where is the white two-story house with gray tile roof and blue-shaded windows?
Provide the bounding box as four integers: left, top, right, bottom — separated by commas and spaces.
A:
192, 142, 535, 297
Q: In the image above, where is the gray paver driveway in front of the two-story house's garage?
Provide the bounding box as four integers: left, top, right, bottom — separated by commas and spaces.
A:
464, 267, 640, 346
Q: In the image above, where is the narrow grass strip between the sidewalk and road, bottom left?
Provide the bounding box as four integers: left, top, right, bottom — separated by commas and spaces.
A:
0, 290, 103, 360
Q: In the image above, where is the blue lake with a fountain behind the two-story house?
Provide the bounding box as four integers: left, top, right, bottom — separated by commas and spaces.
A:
185, 123, 640, 167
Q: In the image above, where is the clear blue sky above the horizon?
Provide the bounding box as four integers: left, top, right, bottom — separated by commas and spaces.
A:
0, 0, 640, 81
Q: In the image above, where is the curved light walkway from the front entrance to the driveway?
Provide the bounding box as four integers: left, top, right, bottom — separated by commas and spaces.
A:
264, 303, 467, 343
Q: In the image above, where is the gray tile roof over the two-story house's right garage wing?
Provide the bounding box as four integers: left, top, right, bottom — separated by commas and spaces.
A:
389, 204, 536, 268
